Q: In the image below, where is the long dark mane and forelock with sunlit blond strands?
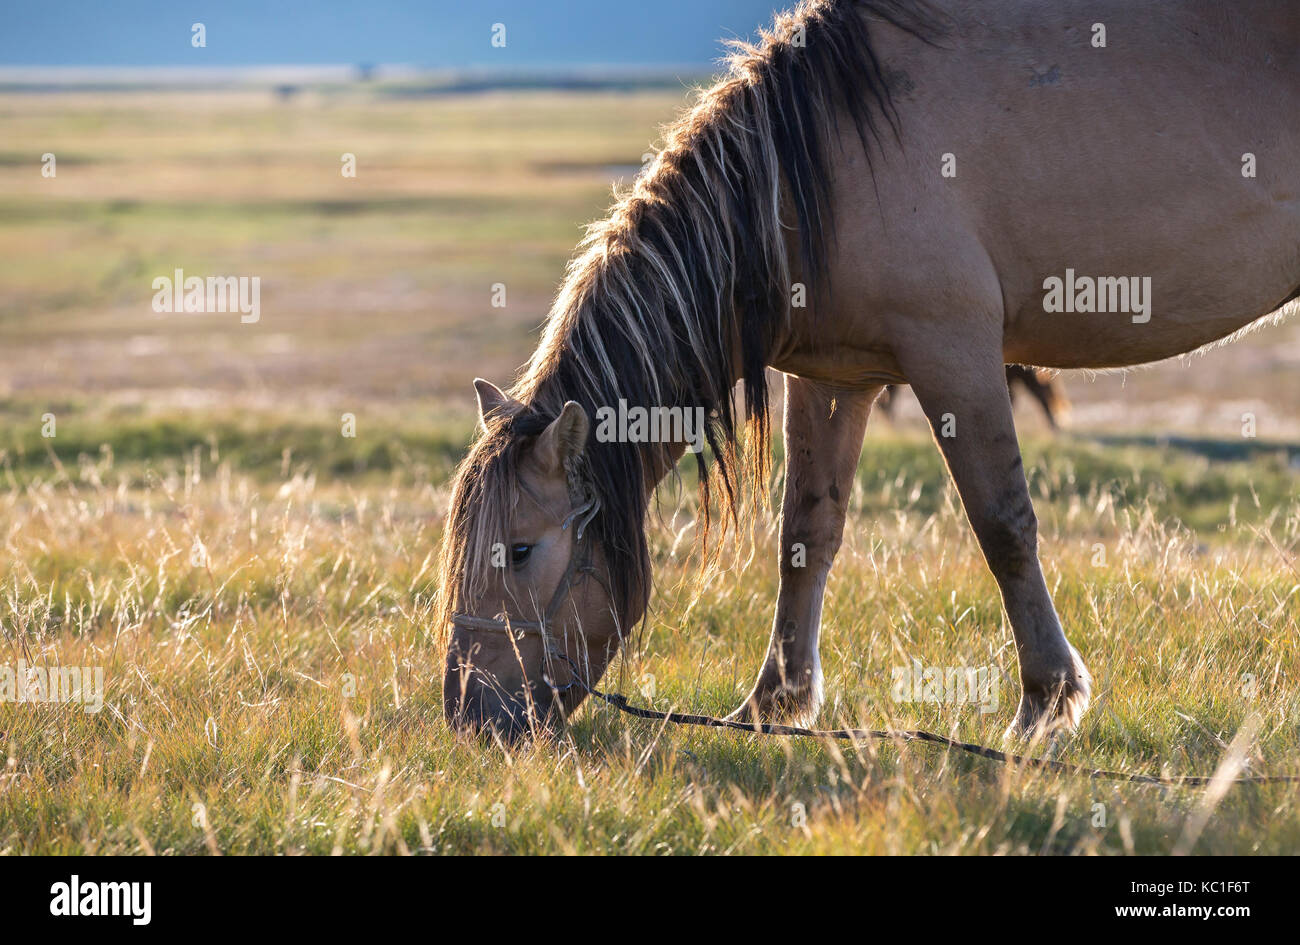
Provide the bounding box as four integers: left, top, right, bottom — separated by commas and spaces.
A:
439, 0, 936, 639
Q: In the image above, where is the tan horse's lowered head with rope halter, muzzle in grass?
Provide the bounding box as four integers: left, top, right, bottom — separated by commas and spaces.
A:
441, 380, 640, 741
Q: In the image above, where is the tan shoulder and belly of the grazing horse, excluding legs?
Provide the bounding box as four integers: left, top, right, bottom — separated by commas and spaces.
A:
811, 1, 1300, 373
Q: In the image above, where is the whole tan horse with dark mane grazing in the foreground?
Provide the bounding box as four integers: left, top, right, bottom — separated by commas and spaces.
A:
438, 0, 1300, 737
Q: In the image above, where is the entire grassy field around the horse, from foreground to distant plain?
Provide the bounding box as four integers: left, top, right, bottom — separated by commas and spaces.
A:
0, 91, 1300, 854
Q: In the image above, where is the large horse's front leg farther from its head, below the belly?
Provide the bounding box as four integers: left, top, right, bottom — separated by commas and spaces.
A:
900, 337, 1091, 736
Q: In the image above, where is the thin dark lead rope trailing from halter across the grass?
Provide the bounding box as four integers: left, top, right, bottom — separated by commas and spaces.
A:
550, 647, 1300, 788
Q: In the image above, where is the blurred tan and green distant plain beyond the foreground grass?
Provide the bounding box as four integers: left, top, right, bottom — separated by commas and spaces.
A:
0, 83, 1300, 441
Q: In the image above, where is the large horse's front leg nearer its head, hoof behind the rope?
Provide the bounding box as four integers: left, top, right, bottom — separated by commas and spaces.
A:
729, 374, 880, 721
